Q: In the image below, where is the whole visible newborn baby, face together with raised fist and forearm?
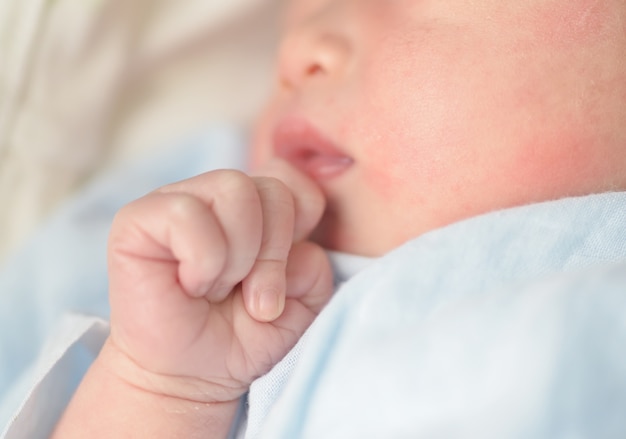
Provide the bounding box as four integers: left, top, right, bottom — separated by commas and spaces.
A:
55, 0, 626, 438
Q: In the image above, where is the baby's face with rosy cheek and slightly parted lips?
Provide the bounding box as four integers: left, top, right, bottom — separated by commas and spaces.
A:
252, 0, 626, 255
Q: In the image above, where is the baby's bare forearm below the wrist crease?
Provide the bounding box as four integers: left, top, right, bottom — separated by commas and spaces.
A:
52, 341, 239, 439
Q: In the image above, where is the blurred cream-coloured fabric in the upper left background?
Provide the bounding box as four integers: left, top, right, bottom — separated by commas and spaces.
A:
0, 0, 282, 262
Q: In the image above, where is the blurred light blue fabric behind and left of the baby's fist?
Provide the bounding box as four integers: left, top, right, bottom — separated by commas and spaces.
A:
0, 126, 245, 439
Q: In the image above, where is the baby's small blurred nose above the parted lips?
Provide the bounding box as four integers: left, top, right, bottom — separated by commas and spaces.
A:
278, 17, 353, 90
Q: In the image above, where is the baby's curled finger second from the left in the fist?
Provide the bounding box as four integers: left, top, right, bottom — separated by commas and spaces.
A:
159, 170, 263, 300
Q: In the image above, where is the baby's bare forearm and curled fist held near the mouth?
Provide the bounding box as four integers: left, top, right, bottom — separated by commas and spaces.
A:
55, 162, 332, 438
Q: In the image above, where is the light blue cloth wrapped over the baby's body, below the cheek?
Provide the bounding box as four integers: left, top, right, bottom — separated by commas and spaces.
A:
246, 193, 626, 439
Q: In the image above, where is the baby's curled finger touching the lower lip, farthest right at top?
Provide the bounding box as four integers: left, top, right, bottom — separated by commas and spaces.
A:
254, 159, 326, 242
